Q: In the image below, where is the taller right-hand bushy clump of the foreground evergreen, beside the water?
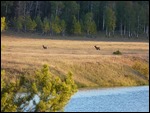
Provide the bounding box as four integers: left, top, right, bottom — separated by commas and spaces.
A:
32, 65, 77, 112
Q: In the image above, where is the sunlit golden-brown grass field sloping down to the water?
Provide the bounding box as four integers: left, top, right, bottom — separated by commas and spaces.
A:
1, 34, 149, 87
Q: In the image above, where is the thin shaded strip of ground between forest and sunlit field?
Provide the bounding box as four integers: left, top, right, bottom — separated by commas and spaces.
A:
1, 31, 149, 43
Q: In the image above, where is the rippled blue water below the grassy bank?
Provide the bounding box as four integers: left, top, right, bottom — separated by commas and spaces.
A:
65, 86, 149, 112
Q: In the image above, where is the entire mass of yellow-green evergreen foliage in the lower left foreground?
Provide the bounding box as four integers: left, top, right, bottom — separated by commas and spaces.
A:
1, 65, 77, 112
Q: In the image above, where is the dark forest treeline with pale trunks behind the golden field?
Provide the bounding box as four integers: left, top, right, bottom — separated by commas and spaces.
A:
1, 1, 149, 37
